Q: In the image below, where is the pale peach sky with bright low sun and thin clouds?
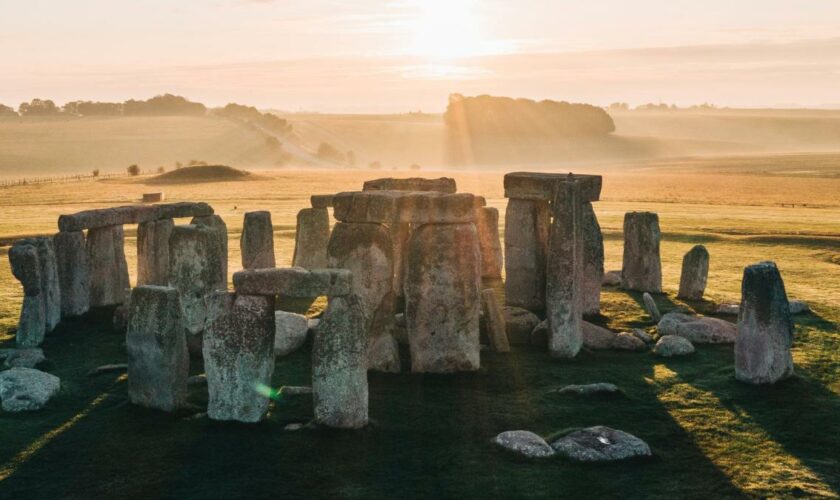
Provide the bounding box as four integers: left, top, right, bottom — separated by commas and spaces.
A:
0, 0, 840, 112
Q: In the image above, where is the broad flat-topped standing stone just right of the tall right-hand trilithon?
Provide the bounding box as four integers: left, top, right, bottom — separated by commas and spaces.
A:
621, 212, 662, 293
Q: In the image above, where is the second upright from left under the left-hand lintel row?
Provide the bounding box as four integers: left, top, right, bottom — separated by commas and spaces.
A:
85, 226, 131, 307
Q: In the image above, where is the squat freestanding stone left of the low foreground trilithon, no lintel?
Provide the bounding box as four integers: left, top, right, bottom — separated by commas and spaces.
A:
125, 285, 190, 411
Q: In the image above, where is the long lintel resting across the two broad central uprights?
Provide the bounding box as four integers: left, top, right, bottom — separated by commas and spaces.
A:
333, 191, 475, 224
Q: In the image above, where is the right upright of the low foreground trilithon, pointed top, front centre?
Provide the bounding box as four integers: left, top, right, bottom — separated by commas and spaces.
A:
312, 295, 368, 429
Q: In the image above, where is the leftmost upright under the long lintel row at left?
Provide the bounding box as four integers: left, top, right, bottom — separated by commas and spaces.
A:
53, 231, 90, 318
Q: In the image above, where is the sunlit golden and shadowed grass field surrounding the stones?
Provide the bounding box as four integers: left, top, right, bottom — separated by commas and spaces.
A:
0, 162, 840, 498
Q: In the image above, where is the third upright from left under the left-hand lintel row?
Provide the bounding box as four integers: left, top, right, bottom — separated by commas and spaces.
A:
137, 219, 175, 286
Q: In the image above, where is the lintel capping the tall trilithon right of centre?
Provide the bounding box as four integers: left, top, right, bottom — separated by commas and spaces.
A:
504, 172, 601, 202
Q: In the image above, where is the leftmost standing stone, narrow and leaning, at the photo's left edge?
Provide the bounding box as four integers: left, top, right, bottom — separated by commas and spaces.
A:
9, 243, 46, 347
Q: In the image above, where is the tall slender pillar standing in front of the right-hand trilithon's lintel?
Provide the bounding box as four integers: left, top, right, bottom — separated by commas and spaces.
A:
545, 180, 584, 358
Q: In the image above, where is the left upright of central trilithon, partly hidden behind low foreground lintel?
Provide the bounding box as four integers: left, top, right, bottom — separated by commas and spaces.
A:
327, 222, 400, 372
